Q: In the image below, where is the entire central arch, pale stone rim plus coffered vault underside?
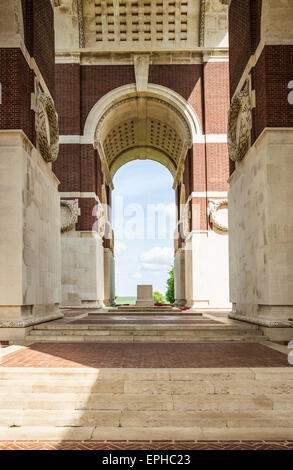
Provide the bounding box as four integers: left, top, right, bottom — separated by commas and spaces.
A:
83, 84, 201, 188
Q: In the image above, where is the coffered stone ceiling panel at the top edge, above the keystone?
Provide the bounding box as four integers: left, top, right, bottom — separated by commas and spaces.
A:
90, 0, 198, 48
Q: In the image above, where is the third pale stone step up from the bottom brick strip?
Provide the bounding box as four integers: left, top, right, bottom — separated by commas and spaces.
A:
0, 388, 293, 412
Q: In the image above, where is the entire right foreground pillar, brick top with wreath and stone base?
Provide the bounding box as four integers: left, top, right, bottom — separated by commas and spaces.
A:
228, 0, 293, 341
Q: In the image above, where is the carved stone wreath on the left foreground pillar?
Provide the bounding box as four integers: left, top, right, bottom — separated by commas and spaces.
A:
36, 92, 59, 162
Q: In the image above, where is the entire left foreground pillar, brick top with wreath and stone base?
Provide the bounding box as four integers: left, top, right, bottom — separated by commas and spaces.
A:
0, 0, 62, 340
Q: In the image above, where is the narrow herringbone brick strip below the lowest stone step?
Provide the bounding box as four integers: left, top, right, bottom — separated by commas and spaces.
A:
0, 440, 293, 450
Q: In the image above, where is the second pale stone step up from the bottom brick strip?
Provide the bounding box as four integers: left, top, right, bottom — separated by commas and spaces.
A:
0, 408, 293, 428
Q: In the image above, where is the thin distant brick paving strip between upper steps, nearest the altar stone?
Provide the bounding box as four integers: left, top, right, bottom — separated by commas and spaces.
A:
71, 315, 222, 326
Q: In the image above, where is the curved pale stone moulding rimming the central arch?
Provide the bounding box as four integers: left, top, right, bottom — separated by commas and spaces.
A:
83, 83, 202, 143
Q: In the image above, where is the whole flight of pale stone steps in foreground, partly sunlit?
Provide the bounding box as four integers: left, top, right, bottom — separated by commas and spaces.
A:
0, 367, 293, 440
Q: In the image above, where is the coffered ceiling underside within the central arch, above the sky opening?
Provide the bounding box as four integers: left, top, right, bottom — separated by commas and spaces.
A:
103, 119, 183, 167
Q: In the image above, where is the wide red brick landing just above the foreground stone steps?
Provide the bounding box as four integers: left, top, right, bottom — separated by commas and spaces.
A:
1, 342, 292, 368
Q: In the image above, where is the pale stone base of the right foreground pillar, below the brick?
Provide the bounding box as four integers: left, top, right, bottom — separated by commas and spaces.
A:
229, 129, 293, 322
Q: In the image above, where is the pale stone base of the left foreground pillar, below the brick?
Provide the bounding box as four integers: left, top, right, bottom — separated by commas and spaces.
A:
0, 131, 62, 340
